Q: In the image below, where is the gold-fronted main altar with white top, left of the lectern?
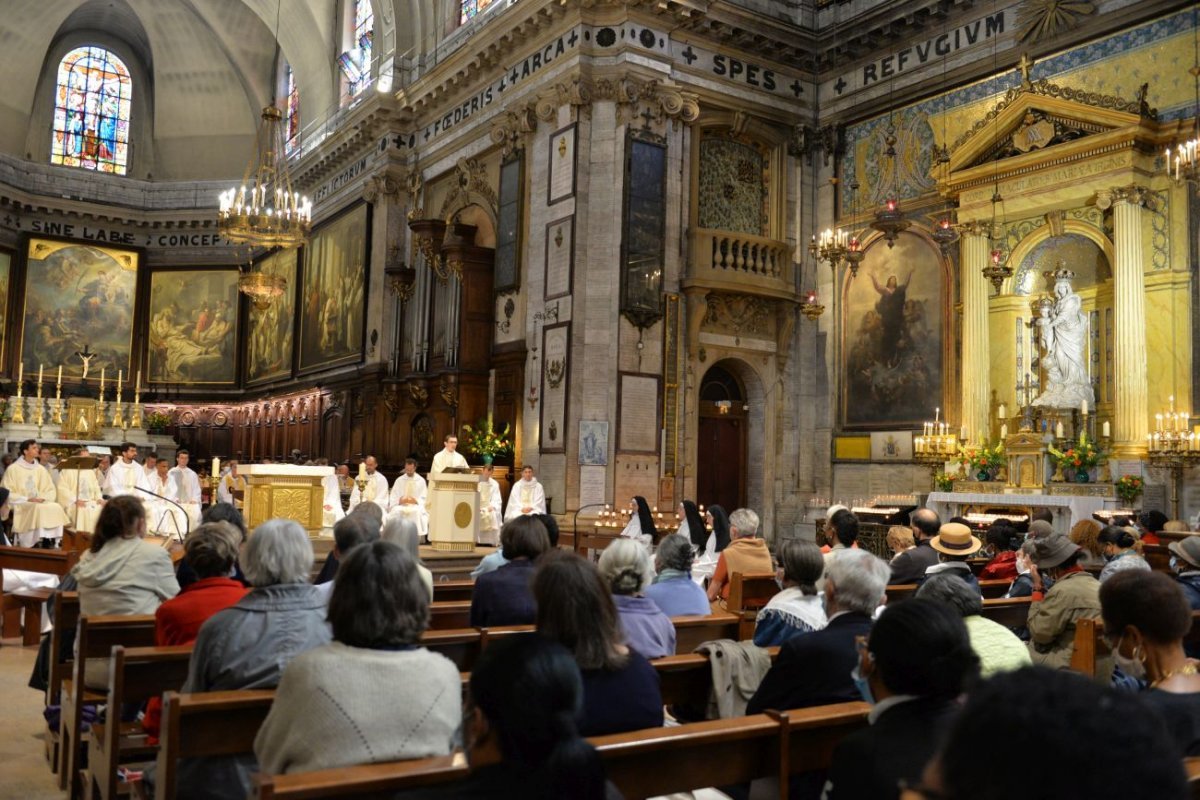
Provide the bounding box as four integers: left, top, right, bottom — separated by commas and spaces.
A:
238, 464, 334, 536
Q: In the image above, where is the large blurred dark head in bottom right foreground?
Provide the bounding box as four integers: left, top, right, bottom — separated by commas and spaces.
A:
905, 671, 1190, 800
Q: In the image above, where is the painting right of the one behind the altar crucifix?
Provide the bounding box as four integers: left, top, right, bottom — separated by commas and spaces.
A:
148, 269, 238, 384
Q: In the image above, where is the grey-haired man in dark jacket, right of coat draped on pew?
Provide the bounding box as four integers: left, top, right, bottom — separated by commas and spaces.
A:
746, 549, 890, 714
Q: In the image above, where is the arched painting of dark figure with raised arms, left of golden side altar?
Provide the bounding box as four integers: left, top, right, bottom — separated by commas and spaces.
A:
841, 234, 946, 429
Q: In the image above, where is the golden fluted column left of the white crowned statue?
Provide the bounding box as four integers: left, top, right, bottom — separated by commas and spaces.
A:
959, 222, 991, 441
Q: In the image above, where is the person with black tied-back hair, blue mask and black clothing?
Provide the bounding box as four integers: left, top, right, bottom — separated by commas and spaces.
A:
822, 599, 979, 800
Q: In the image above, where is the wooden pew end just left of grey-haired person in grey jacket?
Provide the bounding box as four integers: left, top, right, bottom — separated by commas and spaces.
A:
83, 644, 192, 800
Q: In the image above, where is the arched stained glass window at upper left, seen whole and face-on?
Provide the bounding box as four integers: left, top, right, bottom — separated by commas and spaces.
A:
50, 47, 133, 175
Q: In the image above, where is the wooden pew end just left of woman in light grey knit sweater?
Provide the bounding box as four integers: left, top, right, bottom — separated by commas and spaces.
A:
155, 690, 275, 800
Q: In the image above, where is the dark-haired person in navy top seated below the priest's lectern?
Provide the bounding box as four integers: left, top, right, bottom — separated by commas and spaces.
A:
470, 516, 550, 627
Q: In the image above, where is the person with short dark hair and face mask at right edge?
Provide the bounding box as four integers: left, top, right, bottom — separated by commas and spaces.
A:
1100, 571, 1200, 756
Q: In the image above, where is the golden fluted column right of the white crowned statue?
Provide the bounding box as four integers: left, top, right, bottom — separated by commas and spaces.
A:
1097, 185, 1153, 458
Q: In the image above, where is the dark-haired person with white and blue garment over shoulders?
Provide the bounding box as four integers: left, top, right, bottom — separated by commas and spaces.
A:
754, 539, 827, 648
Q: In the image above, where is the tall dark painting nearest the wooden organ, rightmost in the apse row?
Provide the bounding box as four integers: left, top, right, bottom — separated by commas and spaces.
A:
300, 204, 370, 369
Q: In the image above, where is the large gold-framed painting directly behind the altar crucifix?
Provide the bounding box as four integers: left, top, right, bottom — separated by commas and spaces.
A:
20, 239, 140, 379
